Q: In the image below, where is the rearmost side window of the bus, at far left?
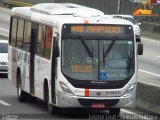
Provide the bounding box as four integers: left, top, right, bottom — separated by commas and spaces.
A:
11, 18, 17, 47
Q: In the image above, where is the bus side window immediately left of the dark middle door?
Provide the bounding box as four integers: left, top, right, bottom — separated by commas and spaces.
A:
23, 21, 31, 51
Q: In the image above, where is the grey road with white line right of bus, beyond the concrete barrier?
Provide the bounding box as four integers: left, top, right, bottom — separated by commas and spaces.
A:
138, 37, 160, 86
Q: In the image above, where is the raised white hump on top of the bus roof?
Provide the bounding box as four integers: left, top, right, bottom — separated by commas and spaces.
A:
31, 3, 104, 16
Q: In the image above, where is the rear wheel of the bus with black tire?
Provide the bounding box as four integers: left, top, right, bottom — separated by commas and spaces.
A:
17, 74, 28, 102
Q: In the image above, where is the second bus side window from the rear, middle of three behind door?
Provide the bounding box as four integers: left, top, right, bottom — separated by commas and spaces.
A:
17, 19, 24, 48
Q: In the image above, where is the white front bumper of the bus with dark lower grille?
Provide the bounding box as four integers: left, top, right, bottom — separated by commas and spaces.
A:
56, 91, 136, 109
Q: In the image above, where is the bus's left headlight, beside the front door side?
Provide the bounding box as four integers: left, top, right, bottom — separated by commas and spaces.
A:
59, 81, 74, 96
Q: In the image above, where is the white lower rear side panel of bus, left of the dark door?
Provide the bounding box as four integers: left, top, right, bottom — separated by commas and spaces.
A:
9, 48, 30, 92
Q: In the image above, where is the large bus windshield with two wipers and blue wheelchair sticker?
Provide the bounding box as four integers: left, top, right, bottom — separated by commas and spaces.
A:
62, 38, 134, 81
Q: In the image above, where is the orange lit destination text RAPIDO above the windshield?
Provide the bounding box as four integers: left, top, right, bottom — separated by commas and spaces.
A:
71, 26, 120, 33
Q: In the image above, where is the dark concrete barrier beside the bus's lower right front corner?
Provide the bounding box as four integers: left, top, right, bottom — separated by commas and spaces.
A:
136, 82, 160, 114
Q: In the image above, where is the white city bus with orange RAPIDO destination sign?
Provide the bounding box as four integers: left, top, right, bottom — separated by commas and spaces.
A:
8, 3, 143, 114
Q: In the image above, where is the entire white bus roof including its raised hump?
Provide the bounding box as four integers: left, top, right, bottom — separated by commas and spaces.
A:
11, 3, 132, 26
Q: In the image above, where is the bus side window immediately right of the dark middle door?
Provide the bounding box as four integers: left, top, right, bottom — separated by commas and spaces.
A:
36, 25, 46, 56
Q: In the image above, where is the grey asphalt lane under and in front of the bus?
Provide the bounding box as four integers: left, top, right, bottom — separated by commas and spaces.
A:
0, 75, 159, 120
